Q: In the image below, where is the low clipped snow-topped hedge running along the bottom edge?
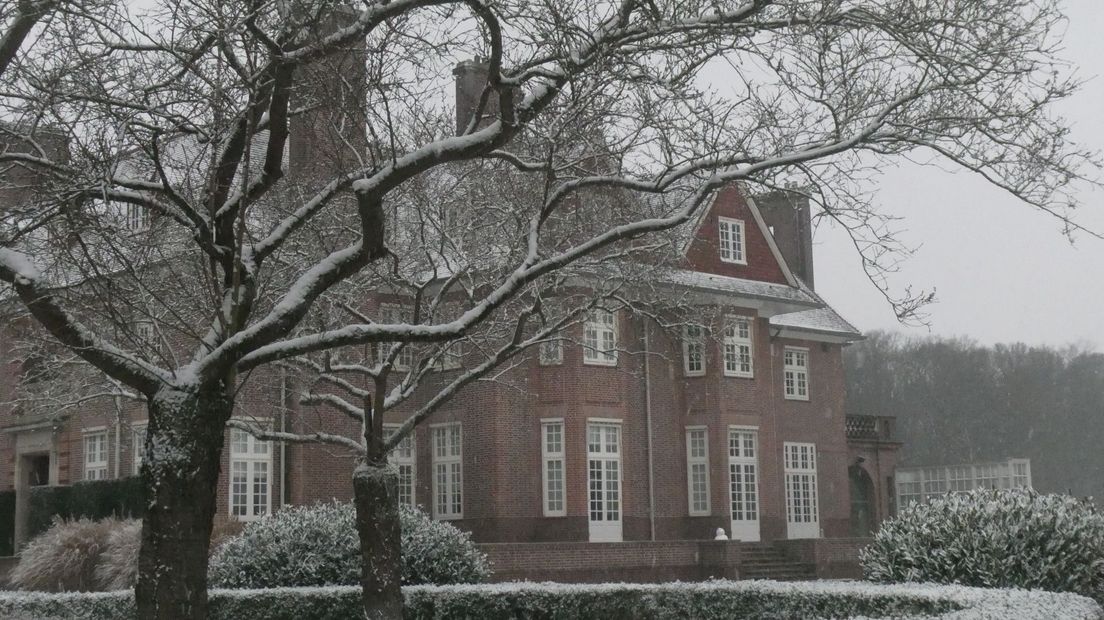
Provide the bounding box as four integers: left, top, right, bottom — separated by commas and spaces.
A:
0, 581, 1104, 620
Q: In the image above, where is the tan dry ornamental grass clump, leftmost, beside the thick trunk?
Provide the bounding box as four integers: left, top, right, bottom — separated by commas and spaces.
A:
8, 517, 132, 592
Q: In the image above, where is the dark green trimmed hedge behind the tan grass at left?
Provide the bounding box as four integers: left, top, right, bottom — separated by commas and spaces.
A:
26, 475, 146, 538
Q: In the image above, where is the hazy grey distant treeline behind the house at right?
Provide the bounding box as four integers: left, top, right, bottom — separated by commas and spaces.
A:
845, 332, 1104, 501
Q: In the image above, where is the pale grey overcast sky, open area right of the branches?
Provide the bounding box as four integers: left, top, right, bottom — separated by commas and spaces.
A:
814, 0, 1104, 351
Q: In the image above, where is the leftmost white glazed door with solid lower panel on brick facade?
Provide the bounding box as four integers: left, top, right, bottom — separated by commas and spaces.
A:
586, 421, 622, 543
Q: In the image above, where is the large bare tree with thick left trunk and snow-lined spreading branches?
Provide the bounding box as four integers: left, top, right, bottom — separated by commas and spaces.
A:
0, 0, 1095, 618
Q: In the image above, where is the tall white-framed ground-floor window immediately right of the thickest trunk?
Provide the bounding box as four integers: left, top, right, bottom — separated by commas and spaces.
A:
230, 421, 272, 521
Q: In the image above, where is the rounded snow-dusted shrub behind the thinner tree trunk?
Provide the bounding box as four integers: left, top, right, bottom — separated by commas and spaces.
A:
209, 502, 490, 588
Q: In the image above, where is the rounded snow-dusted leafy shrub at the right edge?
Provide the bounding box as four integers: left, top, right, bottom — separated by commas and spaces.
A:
860, 489, 1104, 600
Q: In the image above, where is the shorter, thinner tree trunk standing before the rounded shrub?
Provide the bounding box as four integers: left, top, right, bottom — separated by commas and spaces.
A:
352, 461, 403, 620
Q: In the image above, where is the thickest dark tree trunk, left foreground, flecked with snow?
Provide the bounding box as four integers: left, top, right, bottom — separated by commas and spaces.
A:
135, 387, 234, 620
